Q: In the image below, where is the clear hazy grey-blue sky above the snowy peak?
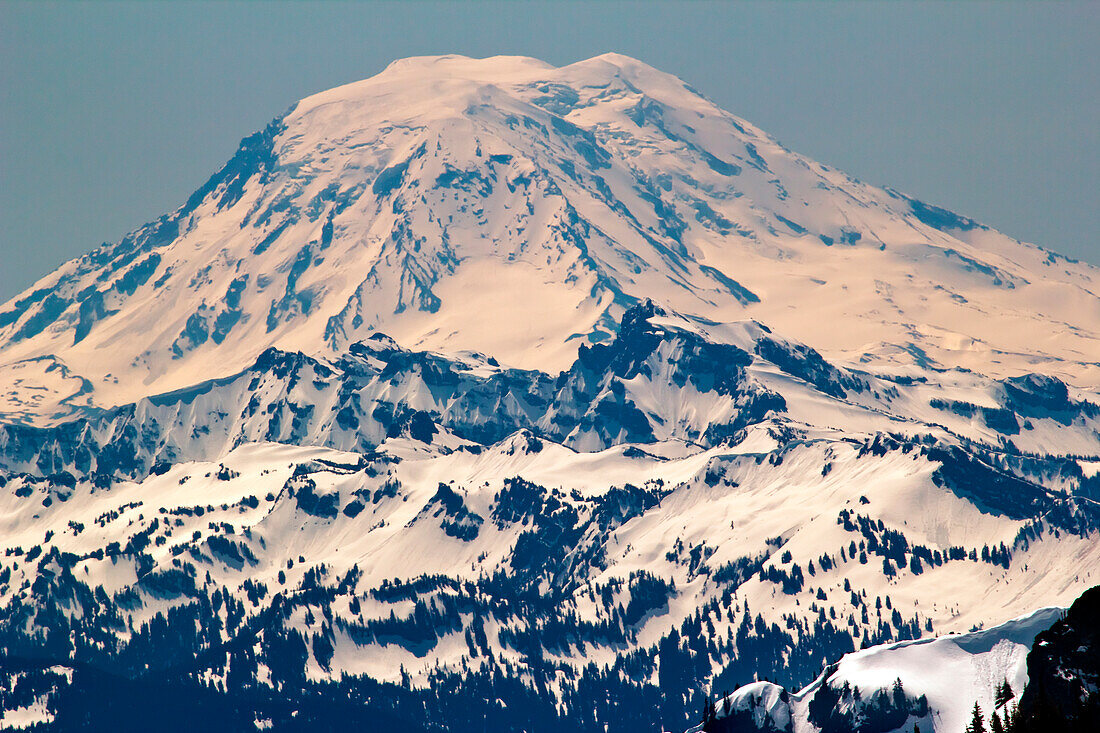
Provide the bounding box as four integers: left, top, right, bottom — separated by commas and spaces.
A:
0, 0, 1100, 300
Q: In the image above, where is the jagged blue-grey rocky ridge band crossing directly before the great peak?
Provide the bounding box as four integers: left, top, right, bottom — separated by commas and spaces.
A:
0, 302, 1100, 490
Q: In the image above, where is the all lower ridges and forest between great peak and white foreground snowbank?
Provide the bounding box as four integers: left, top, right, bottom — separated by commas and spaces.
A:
0, 303, 1100, 731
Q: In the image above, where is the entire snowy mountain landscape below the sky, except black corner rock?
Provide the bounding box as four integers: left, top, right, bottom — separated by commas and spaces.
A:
0, 54, 1100, 733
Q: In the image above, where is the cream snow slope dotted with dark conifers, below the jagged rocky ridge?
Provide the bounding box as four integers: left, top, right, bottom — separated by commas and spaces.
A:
0, 405, 1100, 717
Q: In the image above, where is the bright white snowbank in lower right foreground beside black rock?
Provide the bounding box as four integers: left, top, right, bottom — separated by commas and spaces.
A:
694, 608, 1065, 733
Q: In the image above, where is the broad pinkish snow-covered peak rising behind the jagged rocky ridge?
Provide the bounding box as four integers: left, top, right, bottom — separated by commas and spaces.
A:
0, 54, 1100, 422
